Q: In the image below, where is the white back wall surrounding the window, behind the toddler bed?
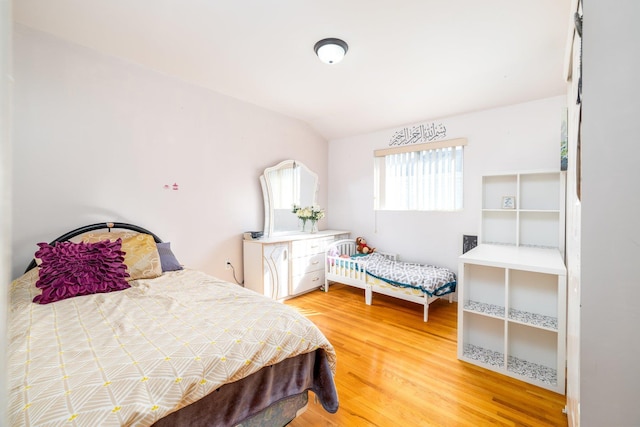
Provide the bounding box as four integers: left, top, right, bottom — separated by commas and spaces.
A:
327, 96, 566, 271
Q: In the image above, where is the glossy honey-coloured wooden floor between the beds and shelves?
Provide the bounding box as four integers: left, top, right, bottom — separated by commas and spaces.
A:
285, 284, 567, 427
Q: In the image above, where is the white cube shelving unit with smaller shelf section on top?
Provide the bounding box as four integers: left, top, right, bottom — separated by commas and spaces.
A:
458, 172, 566, 394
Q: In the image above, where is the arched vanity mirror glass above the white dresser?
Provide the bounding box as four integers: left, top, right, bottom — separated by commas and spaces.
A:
260, 160, 318, 237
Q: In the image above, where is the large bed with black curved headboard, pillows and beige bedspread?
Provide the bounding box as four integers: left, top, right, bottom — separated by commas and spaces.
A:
8, 223, 338, 427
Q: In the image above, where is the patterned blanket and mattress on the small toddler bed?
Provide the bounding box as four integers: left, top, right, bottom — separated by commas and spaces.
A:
358, 252, 456, 297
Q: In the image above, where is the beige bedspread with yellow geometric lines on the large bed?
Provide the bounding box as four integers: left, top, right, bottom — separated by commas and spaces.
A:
9, 269, 336, 427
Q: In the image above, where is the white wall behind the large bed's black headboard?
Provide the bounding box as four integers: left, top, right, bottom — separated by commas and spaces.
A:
12, 27, 327, 281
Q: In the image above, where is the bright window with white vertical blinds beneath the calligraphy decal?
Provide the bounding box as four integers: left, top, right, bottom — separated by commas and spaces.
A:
374, 138, 467, 211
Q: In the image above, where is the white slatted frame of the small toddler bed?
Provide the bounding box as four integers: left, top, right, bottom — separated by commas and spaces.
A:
324, 239, 453, 322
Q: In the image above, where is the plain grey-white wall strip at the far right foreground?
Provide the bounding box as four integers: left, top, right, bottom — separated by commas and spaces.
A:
580, 0, 640, 427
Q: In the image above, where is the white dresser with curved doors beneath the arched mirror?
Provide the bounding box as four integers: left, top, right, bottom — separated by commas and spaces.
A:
243, 230, 349, 300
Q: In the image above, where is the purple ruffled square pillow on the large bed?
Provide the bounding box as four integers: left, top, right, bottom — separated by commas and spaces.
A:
33, 239, 130, 304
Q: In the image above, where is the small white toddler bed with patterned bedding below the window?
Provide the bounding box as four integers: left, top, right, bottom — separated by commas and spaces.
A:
324, 239, 456, 322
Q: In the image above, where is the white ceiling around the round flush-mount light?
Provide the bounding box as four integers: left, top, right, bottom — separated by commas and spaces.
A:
13, 0, 571, 140
